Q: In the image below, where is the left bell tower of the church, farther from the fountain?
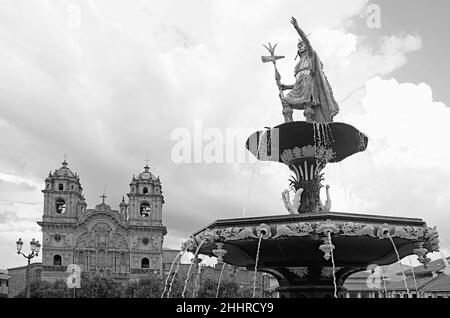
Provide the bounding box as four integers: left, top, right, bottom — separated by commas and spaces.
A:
42, 159, 86, 223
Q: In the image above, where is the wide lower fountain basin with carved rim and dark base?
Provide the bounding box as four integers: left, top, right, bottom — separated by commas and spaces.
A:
189, 212, 439, 297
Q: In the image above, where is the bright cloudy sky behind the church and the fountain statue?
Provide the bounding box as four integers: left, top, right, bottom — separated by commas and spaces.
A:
0, 0, 450, 268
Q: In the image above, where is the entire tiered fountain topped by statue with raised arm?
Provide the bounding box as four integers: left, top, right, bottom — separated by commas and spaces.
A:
187, 18, 439, 298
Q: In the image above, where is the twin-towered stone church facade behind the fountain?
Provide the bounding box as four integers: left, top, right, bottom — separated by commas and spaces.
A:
38, 160, 167, 283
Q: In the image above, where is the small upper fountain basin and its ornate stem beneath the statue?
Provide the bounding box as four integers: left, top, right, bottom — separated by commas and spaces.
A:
246, 121, 368, 213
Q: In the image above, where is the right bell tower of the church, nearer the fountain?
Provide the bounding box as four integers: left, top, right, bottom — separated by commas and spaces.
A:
127, 164, 164, 225
